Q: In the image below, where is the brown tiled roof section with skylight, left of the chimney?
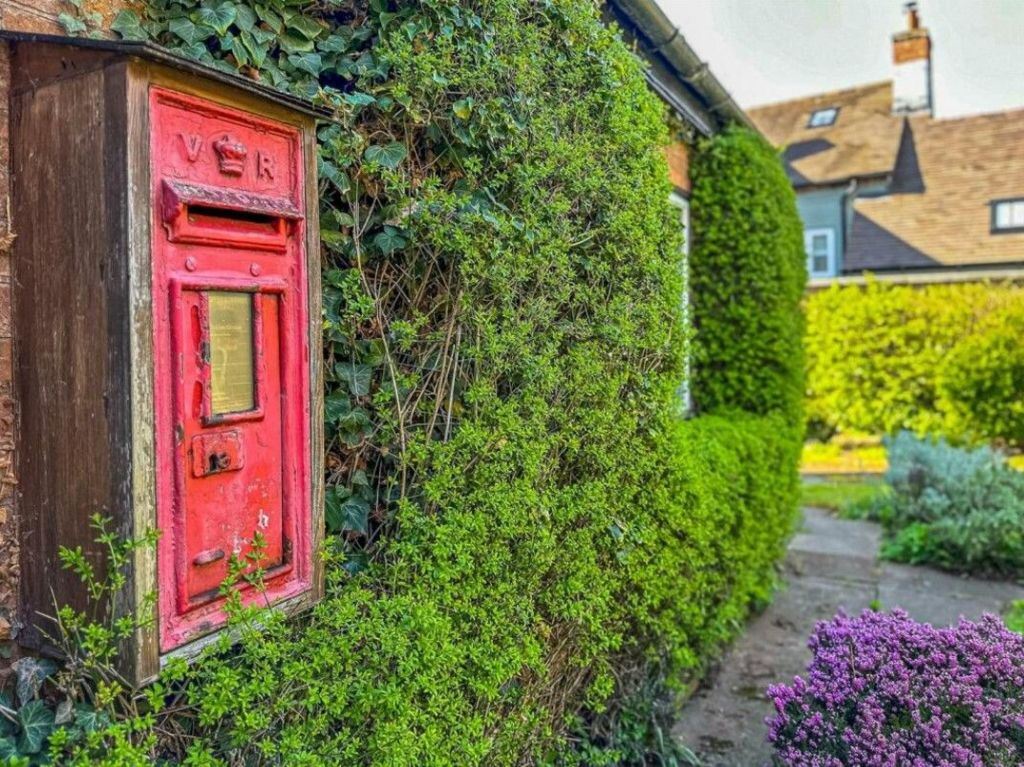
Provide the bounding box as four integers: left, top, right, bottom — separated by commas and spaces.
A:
748, 81, 900, 187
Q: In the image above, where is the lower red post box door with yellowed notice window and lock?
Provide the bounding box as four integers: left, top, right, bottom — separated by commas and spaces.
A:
175, 285, 290, 611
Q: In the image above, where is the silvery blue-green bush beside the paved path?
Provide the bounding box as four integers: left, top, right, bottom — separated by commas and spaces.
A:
883, 432, 1024, 578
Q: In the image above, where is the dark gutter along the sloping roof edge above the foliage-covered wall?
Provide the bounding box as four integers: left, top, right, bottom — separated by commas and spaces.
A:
609, 0, 760, 133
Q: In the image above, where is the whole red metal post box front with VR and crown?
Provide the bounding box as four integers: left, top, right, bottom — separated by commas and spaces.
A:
150, 87, 313, 652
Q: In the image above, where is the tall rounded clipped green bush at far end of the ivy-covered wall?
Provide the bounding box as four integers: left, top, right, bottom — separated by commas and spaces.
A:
690, 128, 807, 420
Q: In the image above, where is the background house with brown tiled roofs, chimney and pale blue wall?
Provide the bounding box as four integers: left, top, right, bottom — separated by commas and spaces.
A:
750, 3, 1024, 288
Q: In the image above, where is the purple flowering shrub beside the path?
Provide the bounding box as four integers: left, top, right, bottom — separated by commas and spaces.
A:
768, 610, 1024, 767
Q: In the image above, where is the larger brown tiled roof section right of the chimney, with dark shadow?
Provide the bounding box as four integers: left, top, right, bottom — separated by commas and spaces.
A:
844, 109, 1024, 271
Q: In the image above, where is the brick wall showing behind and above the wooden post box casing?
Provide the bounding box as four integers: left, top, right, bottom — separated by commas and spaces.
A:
0, 0, 127, 657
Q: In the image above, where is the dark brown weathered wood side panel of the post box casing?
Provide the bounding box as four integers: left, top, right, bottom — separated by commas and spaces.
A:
11, 59, 131, 641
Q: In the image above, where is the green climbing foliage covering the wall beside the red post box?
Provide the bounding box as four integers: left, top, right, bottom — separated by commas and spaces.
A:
28, 0, 802, 767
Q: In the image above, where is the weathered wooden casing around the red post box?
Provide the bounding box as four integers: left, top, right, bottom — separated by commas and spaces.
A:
9, 33, 324, 683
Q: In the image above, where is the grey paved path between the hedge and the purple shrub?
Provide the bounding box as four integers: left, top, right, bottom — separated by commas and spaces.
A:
675, 509, 1024, 767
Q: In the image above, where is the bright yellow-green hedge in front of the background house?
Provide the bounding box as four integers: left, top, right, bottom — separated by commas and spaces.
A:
807, 281, 1024, 443
